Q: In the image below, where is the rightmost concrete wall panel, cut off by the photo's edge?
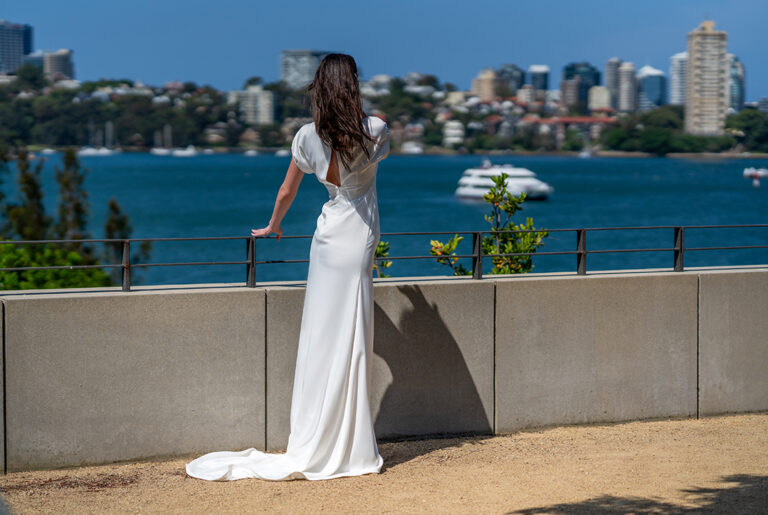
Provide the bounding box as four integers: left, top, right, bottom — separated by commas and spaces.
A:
699, 271, 768, 415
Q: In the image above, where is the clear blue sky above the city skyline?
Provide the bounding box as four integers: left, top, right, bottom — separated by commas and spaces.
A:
6, 0, 768, 101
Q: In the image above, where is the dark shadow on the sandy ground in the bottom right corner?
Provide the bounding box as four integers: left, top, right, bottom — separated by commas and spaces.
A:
508, 474, 768, 515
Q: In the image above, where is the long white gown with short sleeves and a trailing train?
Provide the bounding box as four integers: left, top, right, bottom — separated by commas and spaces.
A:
186, 117, 389, 481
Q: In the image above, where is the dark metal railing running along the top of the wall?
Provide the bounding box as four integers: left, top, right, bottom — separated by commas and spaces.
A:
0, 224, 768, 291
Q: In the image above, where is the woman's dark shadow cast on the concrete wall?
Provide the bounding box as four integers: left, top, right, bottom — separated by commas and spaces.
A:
373, 286, 493, 465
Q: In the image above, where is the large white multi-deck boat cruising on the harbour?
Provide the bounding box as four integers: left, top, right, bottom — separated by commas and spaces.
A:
455, 159, 555, 200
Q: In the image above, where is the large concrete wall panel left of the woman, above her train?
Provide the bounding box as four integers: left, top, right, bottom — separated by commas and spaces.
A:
3, 290, 265, 471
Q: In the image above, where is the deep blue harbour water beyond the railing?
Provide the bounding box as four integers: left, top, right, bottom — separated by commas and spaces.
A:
4, 154, 768, 284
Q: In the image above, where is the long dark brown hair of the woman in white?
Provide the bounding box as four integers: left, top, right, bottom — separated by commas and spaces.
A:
307, 54, 373, 167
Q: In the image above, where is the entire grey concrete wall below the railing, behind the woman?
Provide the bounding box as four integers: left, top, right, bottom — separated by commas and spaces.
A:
0, 268, 768, 471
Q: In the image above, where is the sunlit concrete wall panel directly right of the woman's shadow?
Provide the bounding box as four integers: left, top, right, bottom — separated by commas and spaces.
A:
496, 274, 697, 432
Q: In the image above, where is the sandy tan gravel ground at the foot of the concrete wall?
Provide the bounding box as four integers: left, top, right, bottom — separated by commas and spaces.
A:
0, 413, 768, 514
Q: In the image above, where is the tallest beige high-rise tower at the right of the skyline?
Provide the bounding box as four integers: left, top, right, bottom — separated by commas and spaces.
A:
685, 20, 729, 135
